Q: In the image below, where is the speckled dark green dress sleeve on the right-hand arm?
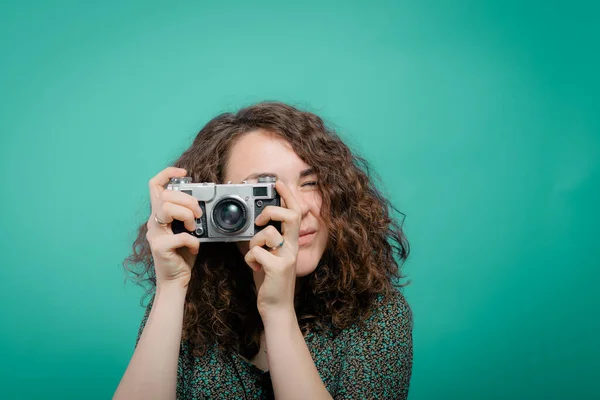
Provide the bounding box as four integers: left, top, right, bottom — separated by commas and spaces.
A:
334, 292, 413, 399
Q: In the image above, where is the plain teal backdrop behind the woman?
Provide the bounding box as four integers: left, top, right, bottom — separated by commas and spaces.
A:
0, 0, 600, 400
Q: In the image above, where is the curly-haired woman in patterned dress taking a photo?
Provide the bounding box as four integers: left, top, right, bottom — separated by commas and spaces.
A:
115, 103, 412, 399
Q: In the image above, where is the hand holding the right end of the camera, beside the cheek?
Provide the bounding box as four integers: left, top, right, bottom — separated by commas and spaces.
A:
244, 181, 302, 319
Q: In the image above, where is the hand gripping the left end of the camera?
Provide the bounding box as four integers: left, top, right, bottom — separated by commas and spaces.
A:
146, 167, 202, 287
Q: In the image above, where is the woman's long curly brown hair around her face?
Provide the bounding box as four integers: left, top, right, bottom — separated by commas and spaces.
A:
123, 102, 409, 358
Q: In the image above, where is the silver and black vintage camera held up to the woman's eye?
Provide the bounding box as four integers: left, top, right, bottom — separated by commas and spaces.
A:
167, 177, 281, 242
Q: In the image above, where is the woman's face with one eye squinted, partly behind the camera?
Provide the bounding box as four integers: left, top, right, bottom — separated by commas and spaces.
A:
225, 130, 329, 277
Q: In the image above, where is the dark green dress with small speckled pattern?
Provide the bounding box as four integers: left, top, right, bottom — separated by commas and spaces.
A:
138, 291, 413, 399
